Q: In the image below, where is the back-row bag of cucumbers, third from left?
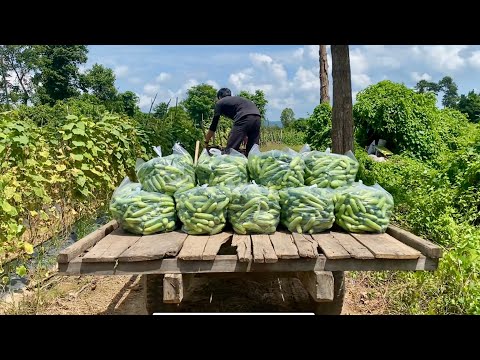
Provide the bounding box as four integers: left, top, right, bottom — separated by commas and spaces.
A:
248, 144, 305, 190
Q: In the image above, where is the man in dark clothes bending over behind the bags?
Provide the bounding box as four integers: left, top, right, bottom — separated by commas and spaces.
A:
205, 88, 260, 155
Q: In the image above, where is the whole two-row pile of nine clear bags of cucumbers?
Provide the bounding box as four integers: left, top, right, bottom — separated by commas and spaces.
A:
110, 144, 393, 235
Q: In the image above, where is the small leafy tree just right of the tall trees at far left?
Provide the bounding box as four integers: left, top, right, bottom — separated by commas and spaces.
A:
80, 64, 117, 102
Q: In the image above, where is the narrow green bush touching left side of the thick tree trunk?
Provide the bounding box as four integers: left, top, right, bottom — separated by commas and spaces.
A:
305, 103, 332, 150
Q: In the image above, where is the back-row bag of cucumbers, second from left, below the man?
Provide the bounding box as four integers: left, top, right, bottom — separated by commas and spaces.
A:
195, 149, 248, 186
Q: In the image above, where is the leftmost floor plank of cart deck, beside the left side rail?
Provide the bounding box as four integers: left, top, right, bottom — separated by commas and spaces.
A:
82, 229, 141, 262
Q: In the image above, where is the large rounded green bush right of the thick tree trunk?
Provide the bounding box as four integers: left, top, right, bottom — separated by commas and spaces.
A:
353, 80, 438, 159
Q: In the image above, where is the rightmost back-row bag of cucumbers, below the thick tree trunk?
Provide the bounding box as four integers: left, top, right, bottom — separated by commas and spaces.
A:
300, 145, 359, 189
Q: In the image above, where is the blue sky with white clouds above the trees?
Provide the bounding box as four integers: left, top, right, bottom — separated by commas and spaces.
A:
83, 45, 480, 121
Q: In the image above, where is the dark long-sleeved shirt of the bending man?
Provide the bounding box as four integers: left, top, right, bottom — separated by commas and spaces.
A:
210, 96, 260, 131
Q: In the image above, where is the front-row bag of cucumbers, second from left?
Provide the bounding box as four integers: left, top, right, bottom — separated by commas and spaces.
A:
175, 185, 230, 235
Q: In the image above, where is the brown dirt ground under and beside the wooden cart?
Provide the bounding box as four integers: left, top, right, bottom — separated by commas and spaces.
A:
0, 273, 386, 315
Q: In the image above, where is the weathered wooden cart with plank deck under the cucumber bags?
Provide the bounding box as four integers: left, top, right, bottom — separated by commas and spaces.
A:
57, 221, 442, 314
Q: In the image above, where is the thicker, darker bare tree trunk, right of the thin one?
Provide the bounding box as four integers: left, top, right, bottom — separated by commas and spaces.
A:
331, 45, 353, 154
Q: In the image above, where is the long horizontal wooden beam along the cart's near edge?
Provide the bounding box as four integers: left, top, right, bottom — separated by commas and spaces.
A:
58, 254, 438, 275
